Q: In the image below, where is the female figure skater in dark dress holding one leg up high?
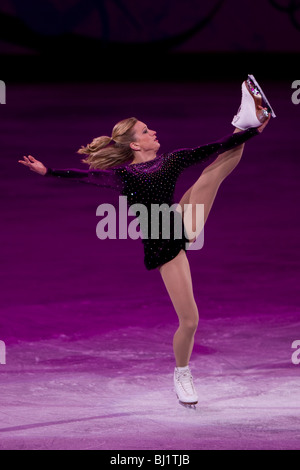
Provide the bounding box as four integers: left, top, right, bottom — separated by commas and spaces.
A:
19, 76, 275, 406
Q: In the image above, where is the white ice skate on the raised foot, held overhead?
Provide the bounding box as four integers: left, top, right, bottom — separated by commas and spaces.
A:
231, 75, 276, 130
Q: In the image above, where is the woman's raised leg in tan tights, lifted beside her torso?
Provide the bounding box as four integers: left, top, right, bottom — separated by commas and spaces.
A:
179, 128, 245, 241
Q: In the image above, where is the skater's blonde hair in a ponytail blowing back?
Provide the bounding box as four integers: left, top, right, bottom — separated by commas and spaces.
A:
77, 117, 138, 169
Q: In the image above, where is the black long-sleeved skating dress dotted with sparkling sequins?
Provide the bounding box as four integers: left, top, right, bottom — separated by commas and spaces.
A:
45, 128, 258, 270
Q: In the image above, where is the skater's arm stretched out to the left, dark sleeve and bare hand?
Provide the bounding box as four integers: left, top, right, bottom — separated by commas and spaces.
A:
19, 155, 121, 191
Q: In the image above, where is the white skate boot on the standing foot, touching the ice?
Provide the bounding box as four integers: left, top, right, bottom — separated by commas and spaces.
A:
174, 366, 198, 407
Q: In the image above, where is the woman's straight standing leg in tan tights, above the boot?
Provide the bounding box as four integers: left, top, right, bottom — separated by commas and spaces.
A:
159, 250, 199, 367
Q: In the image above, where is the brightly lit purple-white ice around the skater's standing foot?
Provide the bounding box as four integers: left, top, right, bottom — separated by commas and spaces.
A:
0, 304, 300, 450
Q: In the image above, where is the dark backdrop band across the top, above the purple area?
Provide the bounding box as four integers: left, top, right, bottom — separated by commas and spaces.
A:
0, 0, 300, 82
